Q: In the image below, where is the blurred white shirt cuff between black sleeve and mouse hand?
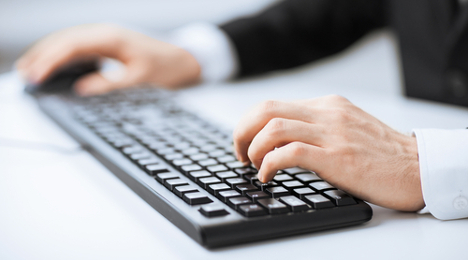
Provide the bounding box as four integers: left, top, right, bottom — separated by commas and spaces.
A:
169, 23, 238, 82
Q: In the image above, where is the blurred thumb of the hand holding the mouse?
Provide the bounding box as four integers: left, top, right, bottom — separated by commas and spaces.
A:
74, 72, 133, 96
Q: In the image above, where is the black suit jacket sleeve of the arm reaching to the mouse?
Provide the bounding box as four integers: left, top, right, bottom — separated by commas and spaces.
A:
221, 0, 387, 77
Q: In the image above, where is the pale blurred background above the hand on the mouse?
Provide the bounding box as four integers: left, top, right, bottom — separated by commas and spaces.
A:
0, 0, 277, 73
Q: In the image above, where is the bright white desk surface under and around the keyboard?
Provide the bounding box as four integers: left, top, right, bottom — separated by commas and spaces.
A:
0, 35, 468, 259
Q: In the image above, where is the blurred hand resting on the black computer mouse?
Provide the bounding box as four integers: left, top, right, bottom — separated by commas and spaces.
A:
17, 24, 200, 95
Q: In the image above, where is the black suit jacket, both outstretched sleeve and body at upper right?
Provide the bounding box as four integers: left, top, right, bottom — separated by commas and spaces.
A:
221, 0, 468, 106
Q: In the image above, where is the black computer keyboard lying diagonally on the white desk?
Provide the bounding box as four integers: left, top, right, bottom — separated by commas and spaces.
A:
30, 88, 372, 247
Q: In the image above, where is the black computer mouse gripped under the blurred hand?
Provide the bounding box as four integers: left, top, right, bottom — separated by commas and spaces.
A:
25, 59, 99, 94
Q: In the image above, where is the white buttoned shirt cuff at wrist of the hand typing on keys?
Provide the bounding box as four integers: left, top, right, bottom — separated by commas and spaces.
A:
413, 129, 468, 220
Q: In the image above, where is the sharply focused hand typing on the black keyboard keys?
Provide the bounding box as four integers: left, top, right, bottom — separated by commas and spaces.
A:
234, 96, 424, 211
